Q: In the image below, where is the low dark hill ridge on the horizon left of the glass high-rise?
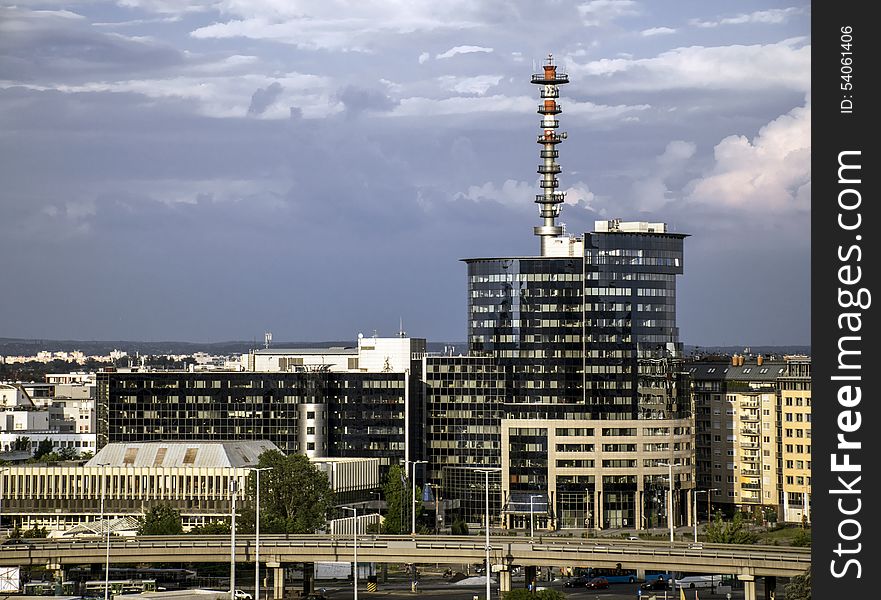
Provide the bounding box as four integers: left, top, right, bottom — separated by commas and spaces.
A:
0, 338, 467, 356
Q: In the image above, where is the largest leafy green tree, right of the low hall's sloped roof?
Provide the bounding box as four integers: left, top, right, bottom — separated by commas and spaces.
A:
242, 450, 333, 533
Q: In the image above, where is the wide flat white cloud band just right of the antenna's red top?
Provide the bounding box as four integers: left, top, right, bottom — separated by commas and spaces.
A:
567, 38, 811, 93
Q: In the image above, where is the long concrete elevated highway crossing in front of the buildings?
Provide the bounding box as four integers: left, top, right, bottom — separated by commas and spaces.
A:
0, 535, 811, 598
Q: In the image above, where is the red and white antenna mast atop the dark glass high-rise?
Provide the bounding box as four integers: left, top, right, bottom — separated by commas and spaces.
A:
532, 54, 569, 256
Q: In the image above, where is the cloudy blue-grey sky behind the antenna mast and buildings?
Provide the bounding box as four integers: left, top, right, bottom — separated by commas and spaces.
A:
0, 0, 811, 346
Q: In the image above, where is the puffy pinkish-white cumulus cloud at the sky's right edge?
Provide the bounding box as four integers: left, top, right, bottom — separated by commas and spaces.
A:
688, 98, 811, 213
